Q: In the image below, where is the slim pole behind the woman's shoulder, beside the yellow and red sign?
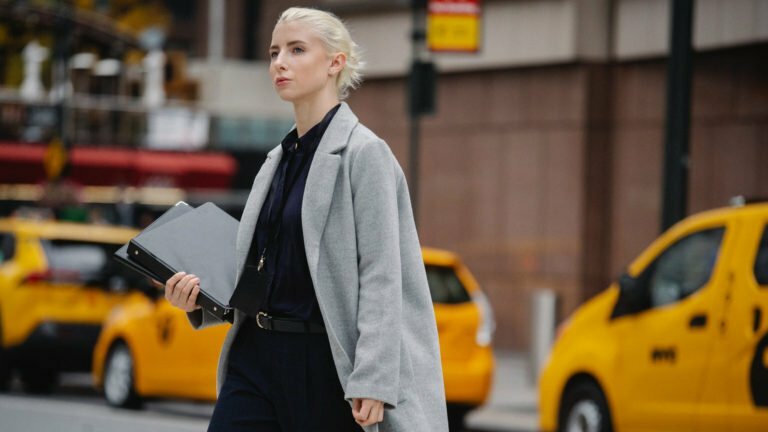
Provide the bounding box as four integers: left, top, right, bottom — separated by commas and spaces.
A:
408, 0, 428, 226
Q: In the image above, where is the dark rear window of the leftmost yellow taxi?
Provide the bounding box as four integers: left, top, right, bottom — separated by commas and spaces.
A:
42, 240, 145, 291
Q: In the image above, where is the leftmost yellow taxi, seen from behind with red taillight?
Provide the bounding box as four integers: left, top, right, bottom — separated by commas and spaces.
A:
0, 218, 147, 392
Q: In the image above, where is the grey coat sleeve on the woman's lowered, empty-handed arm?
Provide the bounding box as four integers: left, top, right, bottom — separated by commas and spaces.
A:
345, 140, 402, 408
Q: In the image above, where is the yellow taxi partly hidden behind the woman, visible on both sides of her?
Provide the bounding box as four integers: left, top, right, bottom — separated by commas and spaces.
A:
93, 248, 494, 422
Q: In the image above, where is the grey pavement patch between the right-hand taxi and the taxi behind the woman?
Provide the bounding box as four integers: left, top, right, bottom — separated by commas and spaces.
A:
467, 350, 538, 432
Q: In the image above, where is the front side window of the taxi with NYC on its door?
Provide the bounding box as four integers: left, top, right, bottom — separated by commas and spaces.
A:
646, 228, 725, 307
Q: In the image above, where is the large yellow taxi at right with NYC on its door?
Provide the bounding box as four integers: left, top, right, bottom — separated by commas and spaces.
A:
539, 204, 768, 432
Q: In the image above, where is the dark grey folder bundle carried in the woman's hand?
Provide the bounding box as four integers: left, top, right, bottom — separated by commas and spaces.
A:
123, 203, 239, 321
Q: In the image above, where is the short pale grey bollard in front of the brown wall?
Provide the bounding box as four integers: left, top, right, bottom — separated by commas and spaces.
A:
528, 289, 557, 385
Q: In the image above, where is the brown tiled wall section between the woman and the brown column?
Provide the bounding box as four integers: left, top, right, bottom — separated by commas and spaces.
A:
350, 66, 585, 348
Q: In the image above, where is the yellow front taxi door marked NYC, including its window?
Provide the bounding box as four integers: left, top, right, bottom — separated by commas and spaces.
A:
615, 218, 736, 432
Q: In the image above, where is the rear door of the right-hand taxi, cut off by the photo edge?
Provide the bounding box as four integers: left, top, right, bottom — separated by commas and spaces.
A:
701, 212, 768, 432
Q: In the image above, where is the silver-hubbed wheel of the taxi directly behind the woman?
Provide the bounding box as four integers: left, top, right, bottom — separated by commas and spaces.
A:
104, 342, 142, 409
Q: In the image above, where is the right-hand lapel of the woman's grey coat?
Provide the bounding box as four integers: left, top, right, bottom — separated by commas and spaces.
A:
301, 102, 358, 289
